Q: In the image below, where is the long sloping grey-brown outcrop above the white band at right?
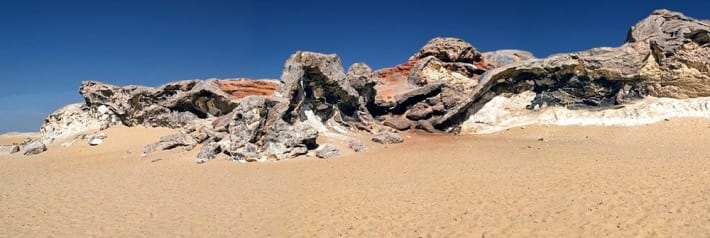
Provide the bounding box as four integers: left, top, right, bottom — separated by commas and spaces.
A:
442, 10, 710, 129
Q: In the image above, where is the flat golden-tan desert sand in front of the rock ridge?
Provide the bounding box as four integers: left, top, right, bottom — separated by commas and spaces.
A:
0, 119, 710, 237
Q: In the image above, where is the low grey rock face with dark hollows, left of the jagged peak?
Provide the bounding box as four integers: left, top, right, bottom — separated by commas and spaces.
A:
79, 80, 237, 128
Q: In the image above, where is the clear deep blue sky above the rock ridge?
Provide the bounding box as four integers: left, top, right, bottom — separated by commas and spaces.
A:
0, 0, 710, 133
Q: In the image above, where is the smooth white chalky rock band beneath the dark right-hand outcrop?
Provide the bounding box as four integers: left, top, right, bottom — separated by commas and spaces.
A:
461, 91, 710, 134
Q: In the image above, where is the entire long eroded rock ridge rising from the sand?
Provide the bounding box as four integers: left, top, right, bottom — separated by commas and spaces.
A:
12, 10, 710, 163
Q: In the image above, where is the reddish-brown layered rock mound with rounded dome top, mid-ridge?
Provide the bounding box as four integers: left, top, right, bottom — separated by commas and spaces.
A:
370, 38, 486, 131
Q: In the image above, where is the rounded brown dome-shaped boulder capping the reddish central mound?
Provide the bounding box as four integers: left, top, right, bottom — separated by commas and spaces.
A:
410, 37, 481, 63
